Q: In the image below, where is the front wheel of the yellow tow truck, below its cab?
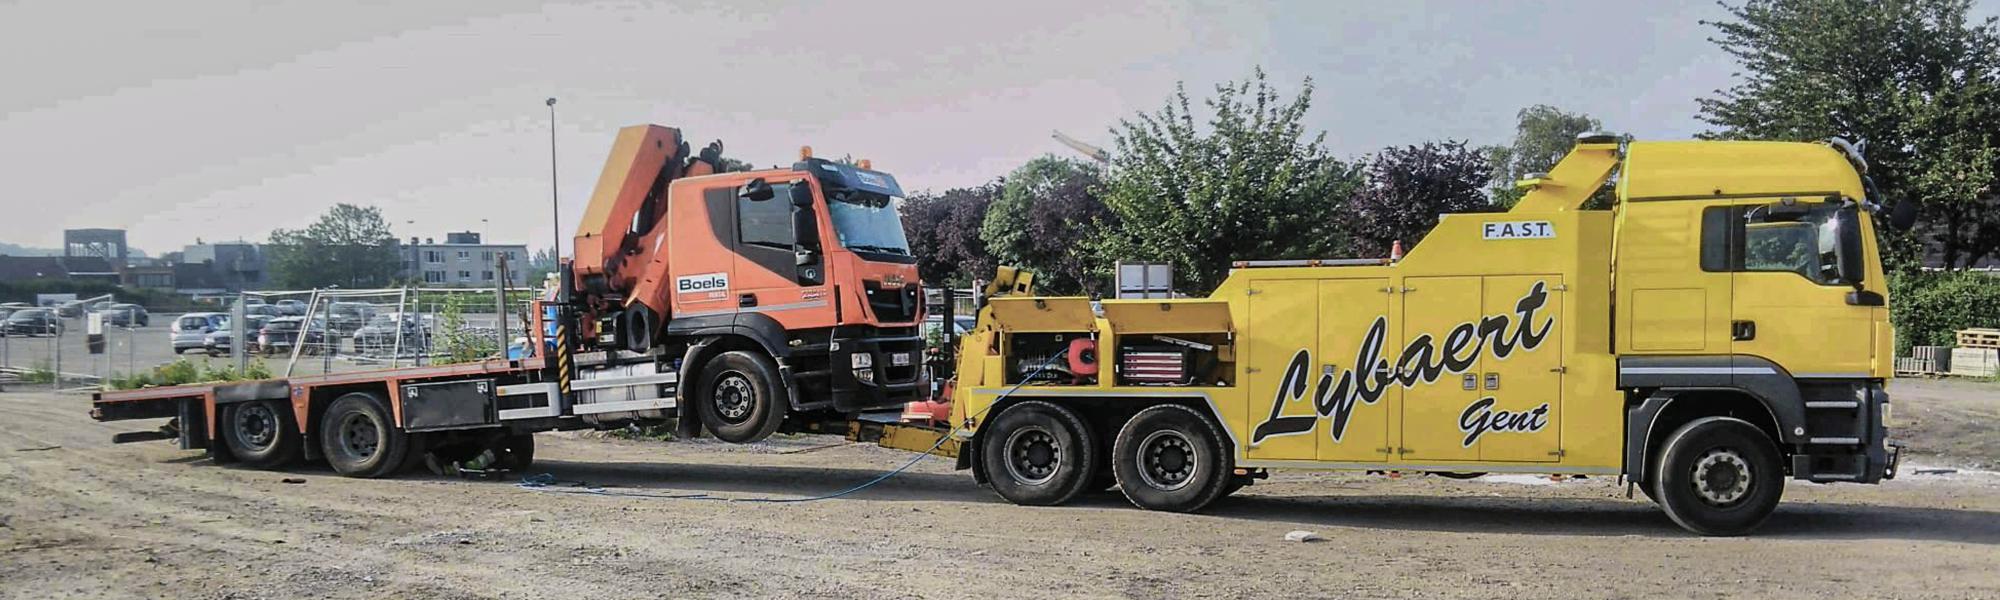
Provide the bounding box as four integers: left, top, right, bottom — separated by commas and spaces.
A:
1652, 416, 1784, 536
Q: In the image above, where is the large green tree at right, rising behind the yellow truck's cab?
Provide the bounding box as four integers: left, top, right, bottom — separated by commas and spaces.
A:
1700, 0, 2000, 270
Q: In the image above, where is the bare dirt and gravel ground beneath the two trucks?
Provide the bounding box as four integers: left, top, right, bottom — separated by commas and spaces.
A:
0, 382, 2000, 598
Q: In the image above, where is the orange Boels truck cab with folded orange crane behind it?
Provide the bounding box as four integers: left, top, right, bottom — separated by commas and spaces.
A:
560, 126, 928, 442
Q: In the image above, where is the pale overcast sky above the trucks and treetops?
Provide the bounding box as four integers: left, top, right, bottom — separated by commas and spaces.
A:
0, 0, 1816, 254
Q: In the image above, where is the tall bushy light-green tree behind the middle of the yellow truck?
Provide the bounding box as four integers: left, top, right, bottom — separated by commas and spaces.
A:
1098, 68, 1360, 294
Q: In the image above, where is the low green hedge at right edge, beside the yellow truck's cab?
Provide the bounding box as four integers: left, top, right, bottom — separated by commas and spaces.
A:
1888, 270, 2000, 356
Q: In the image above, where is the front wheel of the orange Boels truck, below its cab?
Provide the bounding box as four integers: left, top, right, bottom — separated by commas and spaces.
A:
692, 350, 792, 444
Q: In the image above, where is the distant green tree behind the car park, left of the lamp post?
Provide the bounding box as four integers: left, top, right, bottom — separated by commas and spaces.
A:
268, 204, 402, 288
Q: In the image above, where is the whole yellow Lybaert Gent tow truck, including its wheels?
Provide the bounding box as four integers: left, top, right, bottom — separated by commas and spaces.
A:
950, 134, 1898, 534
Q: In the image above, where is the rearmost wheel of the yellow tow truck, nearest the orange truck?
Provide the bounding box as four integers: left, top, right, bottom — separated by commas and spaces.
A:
978, 400, 1098, 506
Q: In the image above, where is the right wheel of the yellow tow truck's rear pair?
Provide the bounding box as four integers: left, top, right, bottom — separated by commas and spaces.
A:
1112, 404, 1232, 512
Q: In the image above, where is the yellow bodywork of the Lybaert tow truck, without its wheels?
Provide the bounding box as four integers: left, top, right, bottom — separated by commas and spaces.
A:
954, 142, 1892, 474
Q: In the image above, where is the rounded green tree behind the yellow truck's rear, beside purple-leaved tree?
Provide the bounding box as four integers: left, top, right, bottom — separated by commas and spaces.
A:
980, 156, 1118, 294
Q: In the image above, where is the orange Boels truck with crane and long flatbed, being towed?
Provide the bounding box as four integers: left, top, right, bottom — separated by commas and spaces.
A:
92, 124, 930, 478
